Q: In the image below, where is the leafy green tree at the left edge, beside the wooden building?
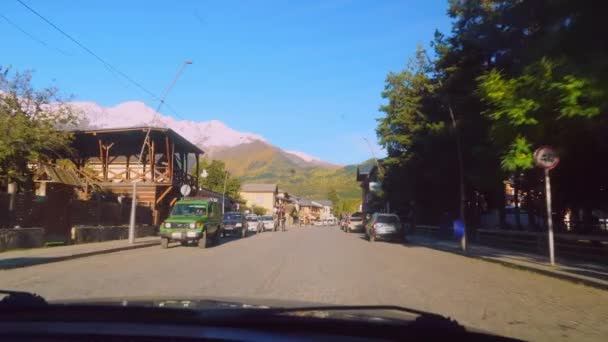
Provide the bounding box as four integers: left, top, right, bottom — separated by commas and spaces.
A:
0, 67, 78, 188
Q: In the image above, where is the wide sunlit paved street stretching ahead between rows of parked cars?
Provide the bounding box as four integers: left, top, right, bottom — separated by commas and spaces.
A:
0, 227, 608, 341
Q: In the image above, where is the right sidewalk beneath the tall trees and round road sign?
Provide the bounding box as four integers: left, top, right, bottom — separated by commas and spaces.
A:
408, 235, 608, 290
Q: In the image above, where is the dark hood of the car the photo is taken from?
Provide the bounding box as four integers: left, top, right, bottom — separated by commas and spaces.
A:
0, 290, 510, 336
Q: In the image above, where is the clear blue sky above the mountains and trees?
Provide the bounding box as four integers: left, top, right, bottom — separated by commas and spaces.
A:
0, 0, 450, 164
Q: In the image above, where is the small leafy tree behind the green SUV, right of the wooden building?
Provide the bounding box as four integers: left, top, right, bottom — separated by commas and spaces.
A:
199, 158, 241, 199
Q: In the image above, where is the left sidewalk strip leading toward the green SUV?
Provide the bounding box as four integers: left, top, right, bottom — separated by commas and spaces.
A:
0, 236, 160, 270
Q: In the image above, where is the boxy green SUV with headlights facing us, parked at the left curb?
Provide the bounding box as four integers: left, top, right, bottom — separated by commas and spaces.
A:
160, 198, 222, 248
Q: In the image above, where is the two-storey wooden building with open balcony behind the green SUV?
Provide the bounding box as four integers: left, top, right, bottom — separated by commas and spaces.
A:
68, 127, 204, 224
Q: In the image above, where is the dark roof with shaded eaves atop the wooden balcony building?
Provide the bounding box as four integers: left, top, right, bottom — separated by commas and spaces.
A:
71, 127, 205, 157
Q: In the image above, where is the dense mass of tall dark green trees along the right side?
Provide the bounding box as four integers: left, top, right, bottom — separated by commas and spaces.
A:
377, 0, 608, 231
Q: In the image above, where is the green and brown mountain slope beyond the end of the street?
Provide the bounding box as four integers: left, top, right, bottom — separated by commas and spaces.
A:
208, 141, 361, 199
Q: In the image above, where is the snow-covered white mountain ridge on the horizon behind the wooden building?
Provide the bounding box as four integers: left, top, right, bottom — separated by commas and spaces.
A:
72, 101, 331, 166
